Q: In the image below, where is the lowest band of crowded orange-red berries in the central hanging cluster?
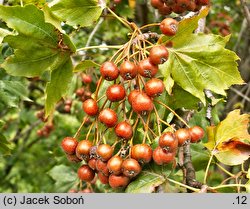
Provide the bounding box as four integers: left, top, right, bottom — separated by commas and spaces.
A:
61, 126, 204, 188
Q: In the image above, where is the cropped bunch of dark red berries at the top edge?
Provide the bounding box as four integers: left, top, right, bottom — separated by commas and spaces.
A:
151, 0, 210, 15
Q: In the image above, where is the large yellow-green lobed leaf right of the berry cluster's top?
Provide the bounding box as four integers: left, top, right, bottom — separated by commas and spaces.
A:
160, 8, 243, 104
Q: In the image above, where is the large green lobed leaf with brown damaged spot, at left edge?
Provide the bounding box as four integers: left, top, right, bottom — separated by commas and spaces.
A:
0, 5, 75, 115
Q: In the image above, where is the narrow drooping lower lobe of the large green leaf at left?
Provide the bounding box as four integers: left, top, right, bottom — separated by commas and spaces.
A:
45, 58, 73, 115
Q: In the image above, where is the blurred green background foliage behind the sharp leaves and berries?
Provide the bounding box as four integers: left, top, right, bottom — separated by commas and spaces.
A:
0, 0, 250, 192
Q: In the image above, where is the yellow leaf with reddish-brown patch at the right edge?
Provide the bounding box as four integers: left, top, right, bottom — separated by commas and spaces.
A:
205, 110, 250, 165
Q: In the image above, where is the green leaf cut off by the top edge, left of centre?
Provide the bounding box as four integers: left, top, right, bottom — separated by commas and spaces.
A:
49, 0, 105, 27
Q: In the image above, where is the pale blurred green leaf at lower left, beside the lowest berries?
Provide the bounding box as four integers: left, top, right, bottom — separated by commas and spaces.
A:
48, 165, 78, 192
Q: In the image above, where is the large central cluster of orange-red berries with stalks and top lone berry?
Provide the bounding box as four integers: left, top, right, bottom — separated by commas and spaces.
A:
61, 18, 204, 188
